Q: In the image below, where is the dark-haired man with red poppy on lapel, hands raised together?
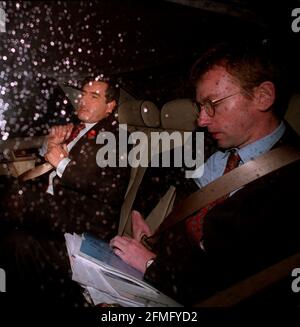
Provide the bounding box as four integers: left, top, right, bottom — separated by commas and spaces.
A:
0, 78, 130, 303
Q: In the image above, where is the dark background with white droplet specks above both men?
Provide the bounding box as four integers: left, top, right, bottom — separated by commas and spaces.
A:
0, 0, 300, 140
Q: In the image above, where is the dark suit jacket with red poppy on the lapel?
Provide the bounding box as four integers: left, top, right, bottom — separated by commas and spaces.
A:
18, 116, 130, 240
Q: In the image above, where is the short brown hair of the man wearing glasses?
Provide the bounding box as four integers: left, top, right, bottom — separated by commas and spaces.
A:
190, 42, 283, 116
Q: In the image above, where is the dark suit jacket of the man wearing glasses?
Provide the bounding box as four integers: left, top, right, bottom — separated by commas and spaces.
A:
145, 124, 300, 304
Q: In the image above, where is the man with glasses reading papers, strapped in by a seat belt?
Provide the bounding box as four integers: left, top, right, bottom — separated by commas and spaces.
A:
111, 44, 300, 304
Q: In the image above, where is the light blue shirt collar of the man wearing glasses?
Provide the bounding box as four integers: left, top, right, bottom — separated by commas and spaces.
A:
224, 121, 286, 163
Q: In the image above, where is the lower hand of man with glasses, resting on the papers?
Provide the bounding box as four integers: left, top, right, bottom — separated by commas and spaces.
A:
109, 236, 156, 273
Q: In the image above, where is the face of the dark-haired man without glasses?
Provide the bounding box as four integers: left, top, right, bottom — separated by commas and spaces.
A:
77, 81, 116, 123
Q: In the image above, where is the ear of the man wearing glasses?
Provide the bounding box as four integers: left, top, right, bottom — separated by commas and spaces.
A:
254, 81, 275, 111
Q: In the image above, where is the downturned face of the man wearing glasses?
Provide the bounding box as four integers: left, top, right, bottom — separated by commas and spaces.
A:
196, 66, 257, 149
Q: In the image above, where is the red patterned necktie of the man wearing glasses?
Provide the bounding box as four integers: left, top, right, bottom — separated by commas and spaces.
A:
186, 151, 241, 244
